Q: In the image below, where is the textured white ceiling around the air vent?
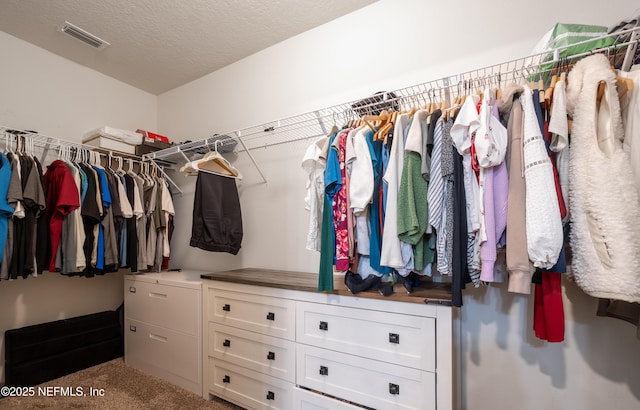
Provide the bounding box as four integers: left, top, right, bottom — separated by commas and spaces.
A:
0, 0, 375, 94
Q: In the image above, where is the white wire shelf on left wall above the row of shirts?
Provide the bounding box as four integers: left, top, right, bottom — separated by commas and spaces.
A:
0, 125, 182, 194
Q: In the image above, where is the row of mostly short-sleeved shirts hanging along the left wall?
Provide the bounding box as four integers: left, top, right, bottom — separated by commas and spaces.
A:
0, 135, 174, 279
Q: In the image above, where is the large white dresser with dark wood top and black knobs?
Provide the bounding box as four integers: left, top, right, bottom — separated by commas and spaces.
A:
203, 269, 454, 410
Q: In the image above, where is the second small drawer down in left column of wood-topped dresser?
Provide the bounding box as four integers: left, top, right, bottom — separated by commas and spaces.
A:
207, 323, 296, 383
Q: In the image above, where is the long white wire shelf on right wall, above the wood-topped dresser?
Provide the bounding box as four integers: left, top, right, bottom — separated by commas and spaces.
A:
143, 27, 640, 182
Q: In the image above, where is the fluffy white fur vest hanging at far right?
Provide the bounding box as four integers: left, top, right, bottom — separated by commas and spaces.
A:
567, 54, 640, 302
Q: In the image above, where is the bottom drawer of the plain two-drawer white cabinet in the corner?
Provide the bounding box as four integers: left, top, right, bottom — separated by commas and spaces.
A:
124, 318, 202, 394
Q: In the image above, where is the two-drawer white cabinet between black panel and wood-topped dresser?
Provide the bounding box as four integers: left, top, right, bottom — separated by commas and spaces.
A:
124, 271, 202, 394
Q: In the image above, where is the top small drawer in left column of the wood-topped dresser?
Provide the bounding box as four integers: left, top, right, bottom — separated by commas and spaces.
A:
206, 288, 296, 340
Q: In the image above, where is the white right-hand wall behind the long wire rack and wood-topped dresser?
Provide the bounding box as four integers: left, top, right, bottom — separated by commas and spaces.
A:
158, 0, 640, 410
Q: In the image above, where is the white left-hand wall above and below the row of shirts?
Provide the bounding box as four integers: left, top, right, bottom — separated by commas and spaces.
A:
0, 31, 157, 380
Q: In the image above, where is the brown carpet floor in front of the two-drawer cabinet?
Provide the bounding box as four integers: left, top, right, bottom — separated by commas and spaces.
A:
0, 358, 242, 410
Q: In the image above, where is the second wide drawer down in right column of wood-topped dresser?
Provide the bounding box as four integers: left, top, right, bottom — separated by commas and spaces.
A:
296, 344, 436, 410
